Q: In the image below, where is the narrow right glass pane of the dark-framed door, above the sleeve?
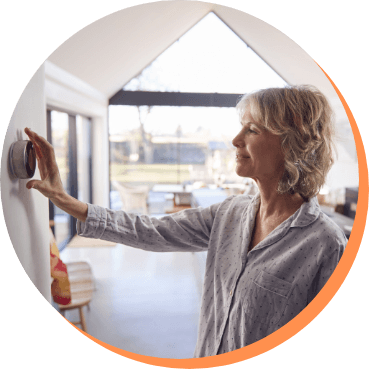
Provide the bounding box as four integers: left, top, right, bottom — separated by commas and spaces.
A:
76, 115, 91, 202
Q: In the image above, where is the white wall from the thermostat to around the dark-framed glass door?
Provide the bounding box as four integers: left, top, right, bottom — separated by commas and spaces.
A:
0, 62, 109, 303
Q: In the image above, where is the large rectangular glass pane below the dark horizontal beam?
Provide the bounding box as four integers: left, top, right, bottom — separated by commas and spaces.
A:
109, 105, 243, 213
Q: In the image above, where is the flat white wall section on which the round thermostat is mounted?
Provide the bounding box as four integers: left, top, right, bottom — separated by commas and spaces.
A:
0, 65, 51, 303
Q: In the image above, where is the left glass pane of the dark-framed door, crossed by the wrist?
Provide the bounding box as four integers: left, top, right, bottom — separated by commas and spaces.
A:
51, 111, 69, 244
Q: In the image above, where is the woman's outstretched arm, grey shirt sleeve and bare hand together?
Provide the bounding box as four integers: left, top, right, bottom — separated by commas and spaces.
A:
25, 128, 220, 252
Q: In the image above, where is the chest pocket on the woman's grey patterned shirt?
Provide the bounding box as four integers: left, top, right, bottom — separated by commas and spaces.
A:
242, 271, 292, 326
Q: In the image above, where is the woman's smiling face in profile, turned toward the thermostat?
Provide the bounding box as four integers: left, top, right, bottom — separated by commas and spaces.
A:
232, 110, 284, 182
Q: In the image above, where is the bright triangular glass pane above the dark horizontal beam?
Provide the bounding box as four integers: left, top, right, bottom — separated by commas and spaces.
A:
123, 13, 287, 94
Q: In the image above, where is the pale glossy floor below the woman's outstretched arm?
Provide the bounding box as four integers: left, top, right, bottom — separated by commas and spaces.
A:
61, 245, 206, 359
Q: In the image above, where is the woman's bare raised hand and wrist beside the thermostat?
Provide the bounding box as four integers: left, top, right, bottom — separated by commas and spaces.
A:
24, 128, 88, 222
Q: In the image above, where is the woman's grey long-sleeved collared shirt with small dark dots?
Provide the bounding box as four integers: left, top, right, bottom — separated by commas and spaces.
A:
77, 193, 347, 357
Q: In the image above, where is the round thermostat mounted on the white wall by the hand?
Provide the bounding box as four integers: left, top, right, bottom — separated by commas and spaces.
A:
9, 140, 36, 179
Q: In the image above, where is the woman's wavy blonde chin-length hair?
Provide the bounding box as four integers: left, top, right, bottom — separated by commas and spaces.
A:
236, 85, 337, 201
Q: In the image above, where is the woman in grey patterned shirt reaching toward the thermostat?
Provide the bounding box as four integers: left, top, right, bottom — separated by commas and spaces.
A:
26, 86, 347, 357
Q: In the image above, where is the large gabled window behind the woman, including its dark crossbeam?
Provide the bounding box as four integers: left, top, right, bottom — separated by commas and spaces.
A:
109, 13, 287, 214
